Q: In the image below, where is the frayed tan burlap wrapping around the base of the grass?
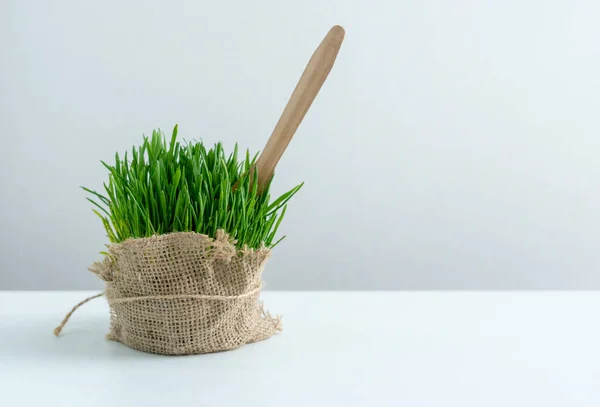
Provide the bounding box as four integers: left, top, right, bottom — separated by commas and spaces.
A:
90, 231, 281, 355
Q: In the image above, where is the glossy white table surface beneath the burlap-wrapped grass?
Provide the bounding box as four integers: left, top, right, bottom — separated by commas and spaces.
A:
0, 292, 600, 407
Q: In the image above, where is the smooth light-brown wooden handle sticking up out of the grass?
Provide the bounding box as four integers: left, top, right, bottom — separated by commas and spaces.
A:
256, 25, 344, 193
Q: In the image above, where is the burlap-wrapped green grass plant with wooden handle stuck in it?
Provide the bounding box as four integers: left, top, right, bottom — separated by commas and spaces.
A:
54, 26, 344, 355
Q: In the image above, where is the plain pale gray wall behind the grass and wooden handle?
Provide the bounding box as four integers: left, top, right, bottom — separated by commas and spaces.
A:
0, 0, 600, 289
